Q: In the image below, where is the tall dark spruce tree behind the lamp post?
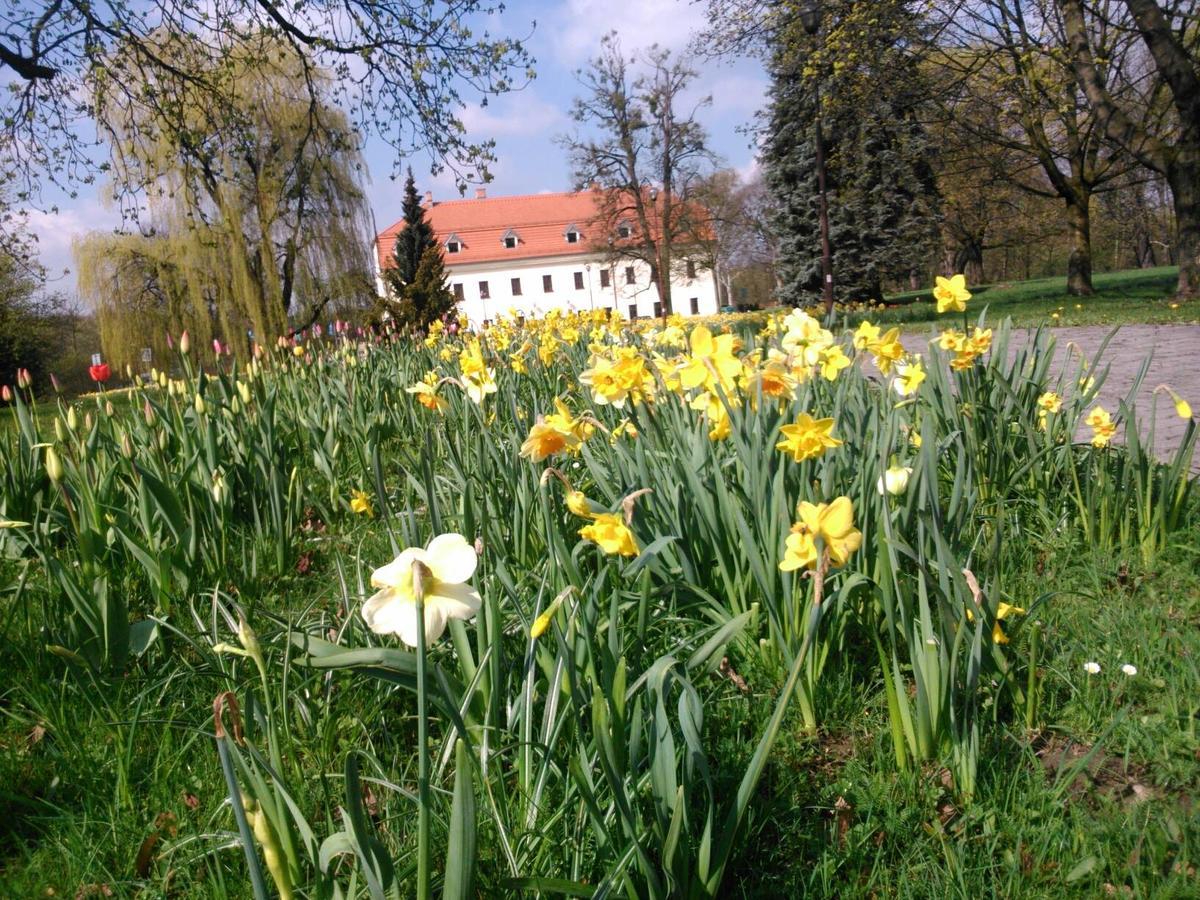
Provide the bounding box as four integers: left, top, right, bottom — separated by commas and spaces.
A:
762, 0, 937, 305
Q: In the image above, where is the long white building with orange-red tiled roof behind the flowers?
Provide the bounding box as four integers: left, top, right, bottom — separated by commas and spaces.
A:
376, 188, 718, 326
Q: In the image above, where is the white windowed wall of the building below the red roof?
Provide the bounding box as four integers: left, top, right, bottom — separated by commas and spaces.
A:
445, 253, 718, 326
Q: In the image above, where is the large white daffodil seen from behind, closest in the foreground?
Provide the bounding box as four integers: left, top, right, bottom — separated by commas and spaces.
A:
362, 534, 480, 647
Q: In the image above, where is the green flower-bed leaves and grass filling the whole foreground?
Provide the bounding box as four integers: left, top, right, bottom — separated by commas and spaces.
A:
0, 309, 1200, 899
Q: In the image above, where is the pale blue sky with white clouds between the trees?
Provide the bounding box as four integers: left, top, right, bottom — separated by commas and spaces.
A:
29, 0, 768, 299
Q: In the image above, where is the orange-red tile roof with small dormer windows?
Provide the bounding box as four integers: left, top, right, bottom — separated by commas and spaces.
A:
376, 190, 696, 268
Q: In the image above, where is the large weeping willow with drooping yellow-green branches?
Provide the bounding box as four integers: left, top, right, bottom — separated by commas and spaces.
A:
74, 34, 374, 365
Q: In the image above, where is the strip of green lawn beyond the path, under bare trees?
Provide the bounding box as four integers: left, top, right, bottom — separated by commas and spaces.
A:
868, 266, 1200, 326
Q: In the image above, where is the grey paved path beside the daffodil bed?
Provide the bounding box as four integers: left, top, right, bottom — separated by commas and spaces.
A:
904, 325, 1200, 464
